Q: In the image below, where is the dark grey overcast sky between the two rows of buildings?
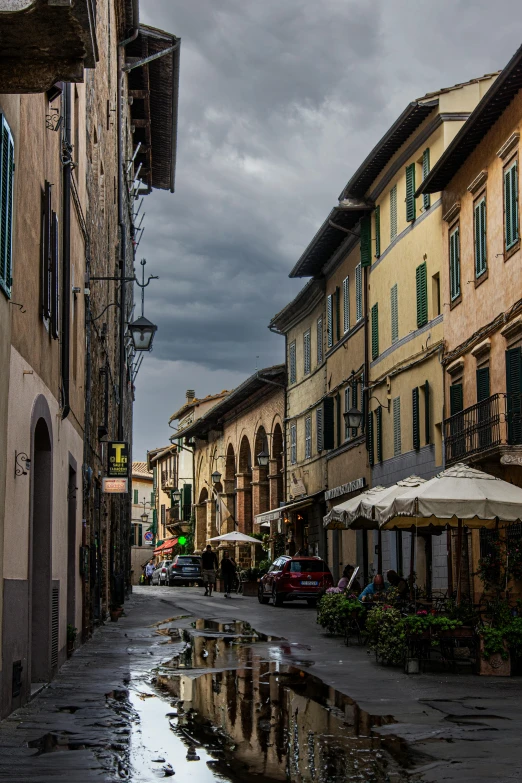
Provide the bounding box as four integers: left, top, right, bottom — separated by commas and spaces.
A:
133, 0, 522, 459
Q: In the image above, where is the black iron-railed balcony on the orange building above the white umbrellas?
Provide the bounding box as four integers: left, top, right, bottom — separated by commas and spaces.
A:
444, 393, 522, 465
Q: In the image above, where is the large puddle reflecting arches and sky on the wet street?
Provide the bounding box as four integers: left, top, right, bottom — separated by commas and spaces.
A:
130, 620, 410, 783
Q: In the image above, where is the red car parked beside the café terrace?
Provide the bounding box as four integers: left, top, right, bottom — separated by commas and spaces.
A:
257, 555, 333, 606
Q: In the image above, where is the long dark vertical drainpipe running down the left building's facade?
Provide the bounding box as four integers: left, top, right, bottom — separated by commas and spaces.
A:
61, 83, 72, 420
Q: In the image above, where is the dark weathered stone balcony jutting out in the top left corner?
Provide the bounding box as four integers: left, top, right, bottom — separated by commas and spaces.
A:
0, 0, 98, 93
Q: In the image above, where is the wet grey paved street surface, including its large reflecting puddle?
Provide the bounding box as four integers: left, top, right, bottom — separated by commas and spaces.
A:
0, 587, 522, 783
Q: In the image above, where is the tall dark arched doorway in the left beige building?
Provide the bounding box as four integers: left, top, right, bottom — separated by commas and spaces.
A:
30, 418, 52, 682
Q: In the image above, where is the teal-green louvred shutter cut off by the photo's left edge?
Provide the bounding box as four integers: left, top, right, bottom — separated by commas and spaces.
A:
0, 114, 14, 297
